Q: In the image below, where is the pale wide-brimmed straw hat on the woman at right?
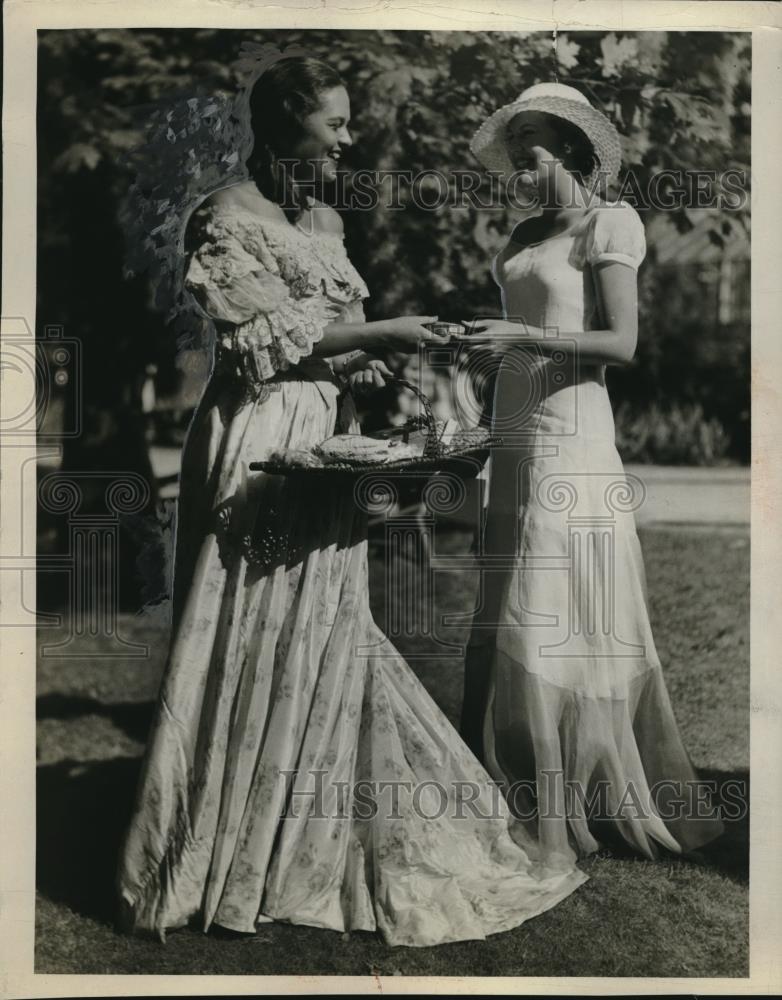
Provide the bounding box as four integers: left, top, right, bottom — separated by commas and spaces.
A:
470, 83, 622, 186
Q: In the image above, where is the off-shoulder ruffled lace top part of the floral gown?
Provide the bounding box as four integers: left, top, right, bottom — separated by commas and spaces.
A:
185, 206, 369, 387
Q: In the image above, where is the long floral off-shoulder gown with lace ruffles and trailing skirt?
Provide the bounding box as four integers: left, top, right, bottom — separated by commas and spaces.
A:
119, 201, 585, 945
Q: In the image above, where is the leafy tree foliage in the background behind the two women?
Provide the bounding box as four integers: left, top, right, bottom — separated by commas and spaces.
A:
38, 29, 751, 462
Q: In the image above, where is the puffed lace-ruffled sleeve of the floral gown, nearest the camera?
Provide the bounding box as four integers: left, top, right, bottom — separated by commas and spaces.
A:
185, 215, 328, 382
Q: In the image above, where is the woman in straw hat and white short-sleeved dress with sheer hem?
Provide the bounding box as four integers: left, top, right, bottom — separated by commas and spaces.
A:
462, 84, 721, 860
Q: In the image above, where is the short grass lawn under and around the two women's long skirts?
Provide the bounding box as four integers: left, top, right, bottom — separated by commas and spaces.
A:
36, 529, 749, 977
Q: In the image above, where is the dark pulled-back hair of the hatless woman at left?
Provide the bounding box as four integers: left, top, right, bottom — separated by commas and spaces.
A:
247, 56, 345, 216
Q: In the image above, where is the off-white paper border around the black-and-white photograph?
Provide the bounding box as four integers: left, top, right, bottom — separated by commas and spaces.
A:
0, 0, 782, 998
